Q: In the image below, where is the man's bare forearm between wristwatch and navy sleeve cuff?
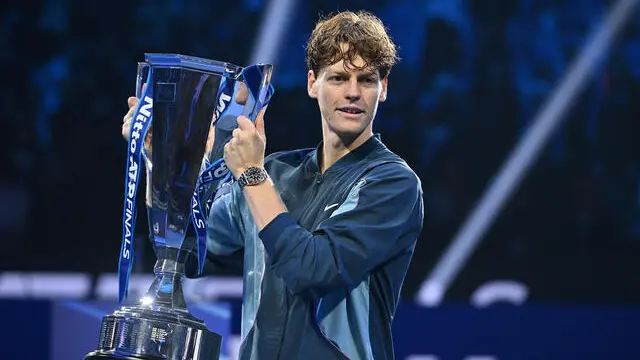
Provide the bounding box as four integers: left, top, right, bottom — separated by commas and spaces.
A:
242, 179, 287, 230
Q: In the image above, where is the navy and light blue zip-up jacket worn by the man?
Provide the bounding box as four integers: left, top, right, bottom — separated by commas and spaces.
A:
190, 136, 423, 360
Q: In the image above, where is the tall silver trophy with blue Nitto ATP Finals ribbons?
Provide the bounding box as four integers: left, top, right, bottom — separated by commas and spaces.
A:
85, 54, 273, 360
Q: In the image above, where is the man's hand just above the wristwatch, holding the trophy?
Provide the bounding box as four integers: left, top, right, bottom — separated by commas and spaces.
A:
224, 108, 267, 179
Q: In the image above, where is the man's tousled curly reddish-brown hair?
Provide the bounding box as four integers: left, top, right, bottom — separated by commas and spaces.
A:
306, 11, 398, 78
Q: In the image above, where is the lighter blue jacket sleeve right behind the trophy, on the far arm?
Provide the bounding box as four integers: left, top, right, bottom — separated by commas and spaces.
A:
186, 183, 244, 278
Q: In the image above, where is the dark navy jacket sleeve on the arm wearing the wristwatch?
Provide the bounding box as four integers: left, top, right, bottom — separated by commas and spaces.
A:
260, 164, 423, 298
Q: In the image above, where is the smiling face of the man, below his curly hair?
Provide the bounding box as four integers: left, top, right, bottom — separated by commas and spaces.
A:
307, 48, 387, 138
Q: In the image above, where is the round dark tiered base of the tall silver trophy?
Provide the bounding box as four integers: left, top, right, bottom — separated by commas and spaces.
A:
84, 306, 222, 360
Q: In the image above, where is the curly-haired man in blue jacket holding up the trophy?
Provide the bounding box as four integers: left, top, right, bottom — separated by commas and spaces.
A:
125, 12, 423, 360
